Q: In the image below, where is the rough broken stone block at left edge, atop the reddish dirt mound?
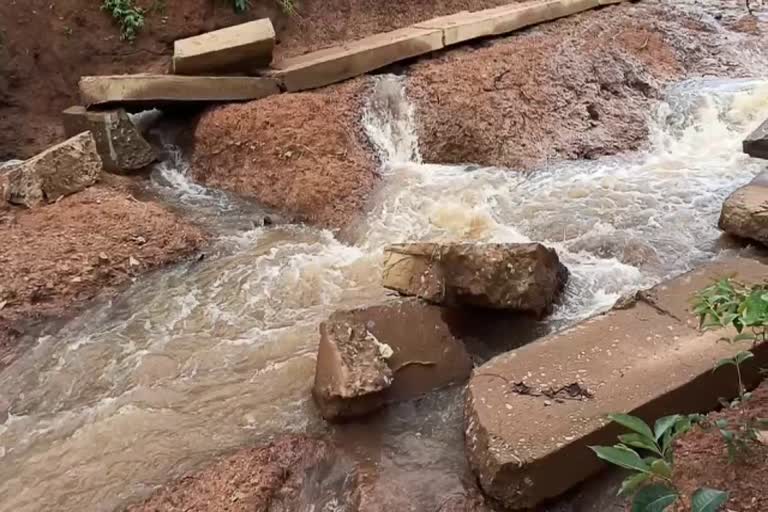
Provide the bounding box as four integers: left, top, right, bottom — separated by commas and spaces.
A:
4, 132, 101, 208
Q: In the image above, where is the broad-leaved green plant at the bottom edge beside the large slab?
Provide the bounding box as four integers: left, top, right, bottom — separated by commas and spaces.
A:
590, 414, 728, 512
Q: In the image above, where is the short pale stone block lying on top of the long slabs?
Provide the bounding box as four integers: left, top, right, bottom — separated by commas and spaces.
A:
173, 18, 275, 75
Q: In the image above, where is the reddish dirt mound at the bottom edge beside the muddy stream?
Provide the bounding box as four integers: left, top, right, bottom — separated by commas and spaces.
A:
128, 436, 330, 512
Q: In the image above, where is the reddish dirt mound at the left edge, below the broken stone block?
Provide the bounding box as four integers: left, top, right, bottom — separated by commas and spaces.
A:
0, 184, 205, 369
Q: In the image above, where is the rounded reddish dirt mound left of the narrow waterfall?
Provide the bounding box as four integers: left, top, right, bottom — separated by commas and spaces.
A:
192, 79, 377, 227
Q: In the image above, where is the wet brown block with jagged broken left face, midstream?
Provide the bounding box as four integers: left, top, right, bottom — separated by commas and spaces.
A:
312, 299, 472, 420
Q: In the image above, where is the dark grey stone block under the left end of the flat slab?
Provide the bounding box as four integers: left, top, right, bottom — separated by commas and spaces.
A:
62, 106, 157, 173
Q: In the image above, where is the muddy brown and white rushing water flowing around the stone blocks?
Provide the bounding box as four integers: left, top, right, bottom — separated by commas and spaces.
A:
0, 69, 768, 512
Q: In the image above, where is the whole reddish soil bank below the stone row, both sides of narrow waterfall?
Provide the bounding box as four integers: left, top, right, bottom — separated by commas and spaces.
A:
189, 0, 764, 228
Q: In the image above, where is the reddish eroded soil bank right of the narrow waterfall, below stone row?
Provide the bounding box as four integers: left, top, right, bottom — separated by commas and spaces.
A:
409, 2, 759, 169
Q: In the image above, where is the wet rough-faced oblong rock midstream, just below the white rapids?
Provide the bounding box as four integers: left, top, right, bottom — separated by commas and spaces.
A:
383, 243, 568, 316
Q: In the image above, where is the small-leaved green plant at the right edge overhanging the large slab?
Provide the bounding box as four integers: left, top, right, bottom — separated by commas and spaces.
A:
694, 279, 768, 463
